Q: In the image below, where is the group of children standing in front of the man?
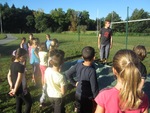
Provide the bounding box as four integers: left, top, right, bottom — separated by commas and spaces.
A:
8, 35, 149, 113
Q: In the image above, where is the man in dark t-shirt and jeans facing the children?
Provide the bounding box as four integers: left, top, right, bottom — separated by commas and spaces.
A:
98, 20, 113, 63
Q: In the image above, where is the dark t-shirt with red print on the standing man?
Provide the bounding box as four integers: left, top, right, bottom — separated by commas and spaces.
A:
100, 28, 112, 45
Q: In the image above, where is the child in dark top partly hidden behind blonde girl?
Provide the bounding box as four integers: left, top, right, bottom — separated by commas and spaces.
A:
133, 45, 147, 90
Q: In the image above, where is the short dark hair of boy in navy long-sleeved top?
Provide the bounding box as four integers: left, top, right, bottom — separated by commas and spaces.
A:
82, 46, 95, 61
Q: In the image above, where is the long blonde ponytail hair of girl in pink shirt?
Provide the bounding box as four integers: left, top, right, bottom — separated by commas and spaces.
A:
113, 50, 143, 110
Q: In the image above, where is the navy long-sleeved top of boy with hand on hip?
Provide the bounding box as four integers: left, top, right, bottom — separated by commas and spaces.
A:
66, 62, 98, 99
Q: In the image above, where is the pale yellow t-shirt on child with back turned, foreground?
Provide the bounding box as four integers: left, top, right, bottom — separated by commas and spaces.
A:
45, 67, 66, 98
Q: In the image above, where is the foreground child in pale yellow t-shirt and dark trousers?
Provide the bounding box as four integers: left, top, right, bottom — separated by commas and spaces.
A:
45, 50, 65, 113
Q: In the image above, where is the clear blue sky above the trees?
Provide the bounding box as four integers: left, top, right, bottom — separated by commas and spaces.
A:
0, 0, 150, 20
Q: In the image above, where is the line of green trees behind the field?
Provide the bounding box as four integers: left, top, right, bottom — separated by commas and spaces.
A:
0, 3, 150, 33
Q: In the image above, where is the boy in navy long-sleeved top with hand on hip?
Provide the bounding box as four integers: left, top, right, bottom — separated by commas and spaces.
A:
66, 46, 98, 113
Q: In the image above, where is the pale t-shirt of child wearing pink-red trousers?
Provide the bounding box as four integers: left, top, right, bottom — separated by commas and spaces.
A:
38, 51, 48, 66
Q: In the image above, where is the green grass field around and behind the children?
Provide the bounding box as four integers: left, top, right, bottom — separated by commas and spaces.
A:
0, 33, 150, 113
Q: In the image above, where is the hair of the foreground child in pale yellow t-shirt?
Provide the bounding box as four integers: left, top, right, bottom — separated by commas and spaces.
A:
50, 49, 65, 67
